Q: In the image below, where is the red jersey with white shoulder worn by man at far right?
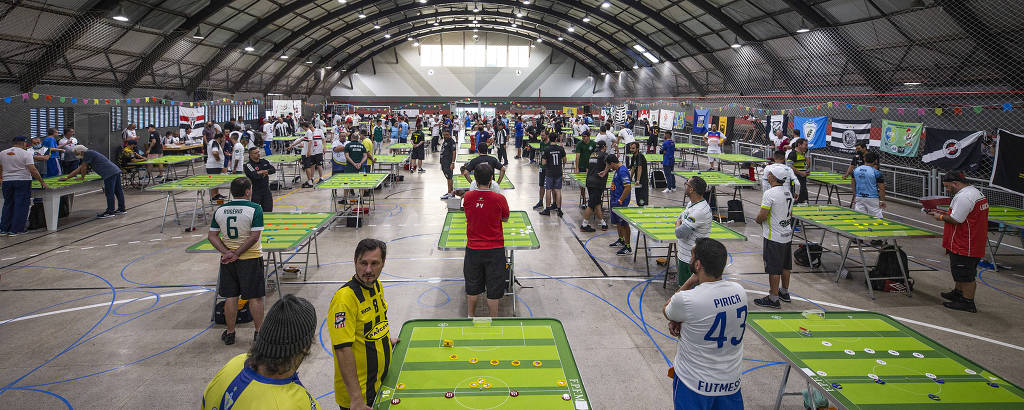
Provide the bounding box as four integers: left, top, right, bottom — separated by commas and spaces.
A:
942, 186, 988, 257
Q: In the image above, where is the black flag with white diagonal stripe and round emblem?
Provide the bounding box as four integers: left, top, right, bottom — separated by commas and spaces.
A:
921, 127, 985, 171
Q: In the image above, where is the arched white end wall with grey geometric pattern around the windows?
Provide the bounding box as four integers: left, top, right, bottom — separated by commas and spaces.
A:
331, 33, 611, 97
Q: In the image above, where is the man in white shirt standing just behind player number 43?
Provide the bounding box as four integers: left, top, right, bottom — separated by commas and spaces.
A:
676, 176, 713, 286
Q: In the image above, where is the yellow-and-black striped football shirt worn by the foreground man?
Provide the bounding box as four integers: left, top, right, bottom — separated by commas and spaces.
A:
328, 278, 391, 407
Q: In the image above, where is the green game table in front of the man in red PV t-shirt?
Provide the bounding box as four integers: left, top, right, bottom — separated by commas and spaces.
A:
437, 211, 541, 316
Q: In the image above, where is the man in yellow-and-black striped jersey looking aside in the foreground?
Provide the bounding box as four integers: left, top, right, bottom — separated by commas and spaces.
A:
328, 238, 397, 410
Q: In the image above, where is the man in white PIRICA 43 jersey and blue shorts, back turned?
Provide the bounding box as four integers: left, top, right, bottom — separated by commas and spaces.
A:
663, 238, 746, 410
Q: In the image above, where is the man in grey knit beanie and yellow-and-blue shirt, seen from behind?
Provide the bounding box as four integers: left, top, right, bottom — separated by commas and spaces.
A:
203, 294, 321, 410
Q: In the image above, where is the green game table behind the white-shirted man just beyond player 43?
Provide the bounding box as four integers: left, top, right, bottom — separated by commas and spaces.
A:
611, 206, 746, 280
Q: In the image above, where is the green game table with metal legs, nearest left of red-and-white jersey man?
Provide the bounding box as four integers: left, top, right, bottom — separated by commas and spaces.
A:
793, 205, 942, 299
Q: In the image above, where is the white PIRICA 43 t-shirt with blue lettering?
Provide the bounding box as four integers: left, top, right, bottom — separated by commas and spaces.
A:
665, 280, 746, 396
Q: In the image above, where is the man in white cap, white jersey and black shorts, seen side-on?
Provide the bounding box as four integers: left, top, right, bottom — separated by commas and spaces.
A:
754, 168, 794, 309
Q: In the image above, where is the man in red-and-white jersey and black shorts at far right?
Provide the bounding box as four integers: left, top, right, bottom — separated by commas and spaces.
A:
931, 172, 988, 313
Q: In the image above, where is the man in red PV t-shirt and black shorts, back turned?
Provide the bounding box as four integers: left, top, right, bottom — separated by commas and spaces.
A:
462, 163, 509, 318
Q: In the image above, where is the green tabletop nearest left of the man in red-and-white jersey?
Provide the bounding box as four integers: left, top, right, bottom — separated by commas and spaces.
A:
793, 205, 942, 239
